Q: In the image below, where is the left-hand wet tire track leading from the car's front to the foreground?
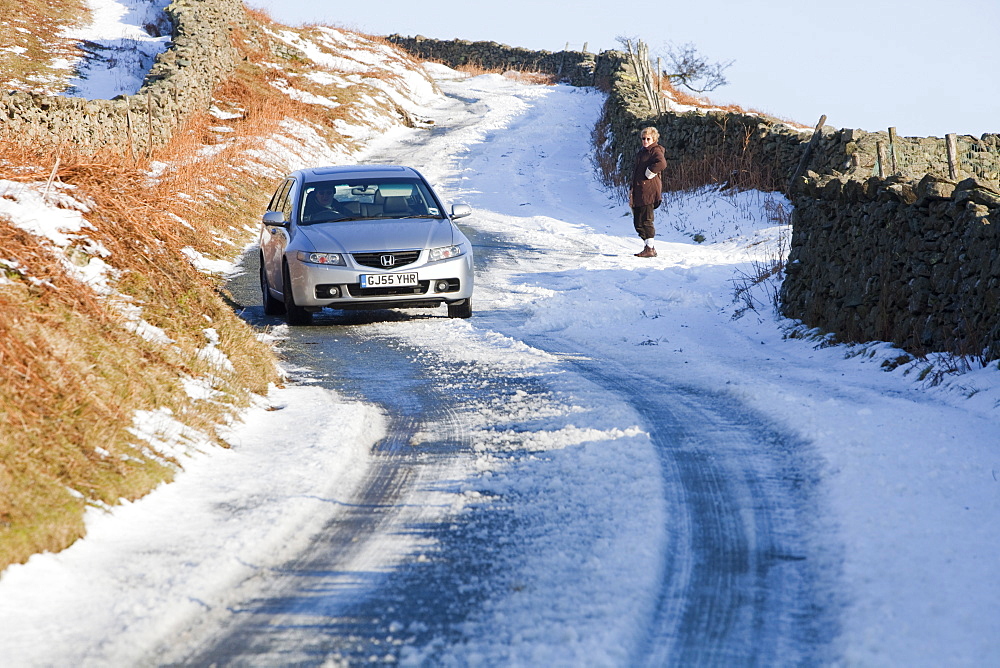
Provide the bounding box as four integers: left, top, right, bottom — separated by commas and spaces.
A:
171, 308, 488, 665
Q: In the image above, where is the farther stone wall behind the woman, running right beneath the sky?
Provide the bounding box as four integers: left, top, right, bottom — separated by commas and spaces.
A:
595, 51, 1000, 196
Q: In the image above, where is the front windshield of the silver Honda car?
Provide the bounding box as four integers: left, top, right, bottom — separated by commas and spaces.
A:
299, 178, 444, 225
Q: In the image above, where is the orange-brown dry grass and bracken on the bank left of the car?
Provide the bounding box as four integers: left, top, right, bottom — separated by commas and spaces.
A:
0, 45, 310, 568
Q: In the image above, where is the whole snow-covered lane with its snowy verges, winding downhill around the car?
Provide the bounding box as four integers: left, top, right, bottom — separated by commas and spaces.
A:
0, 65, 1000, 666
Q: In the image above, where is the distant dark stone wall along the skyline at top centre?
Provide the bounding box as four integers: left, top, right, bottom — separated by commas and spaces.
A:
389, 35, 596, 86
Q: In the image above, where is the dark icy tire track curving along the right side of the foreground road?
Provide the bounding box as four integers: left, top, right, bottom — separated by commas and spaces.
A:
556, 360, 839, 666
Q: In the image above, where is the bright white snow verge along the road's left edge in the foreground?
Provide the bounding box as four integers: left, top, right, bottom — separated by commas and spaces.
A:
0, 386, 384, 666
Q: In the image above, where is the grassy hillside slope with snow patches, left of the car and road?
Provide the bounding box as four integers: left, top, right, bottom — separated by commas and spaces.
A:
0, 3, 442, 568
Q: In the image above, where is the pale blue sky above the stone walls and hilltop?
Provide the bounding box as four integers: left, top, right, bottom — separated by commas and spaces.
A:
248, 0, 1000, 136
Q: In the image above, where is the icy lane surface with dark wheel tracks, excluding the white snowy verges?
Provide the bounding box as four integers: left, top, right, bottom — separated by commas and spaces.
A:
170, 70, 838, 665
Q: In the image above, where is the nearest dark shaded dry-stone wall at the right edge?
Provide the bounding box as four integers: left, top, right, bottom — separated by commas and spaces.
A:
781, 173, 1000, 359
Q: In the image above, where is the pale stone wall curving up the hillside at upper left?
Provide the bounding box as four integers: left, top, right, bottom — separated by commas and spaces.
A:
0, 0, 248, 153
